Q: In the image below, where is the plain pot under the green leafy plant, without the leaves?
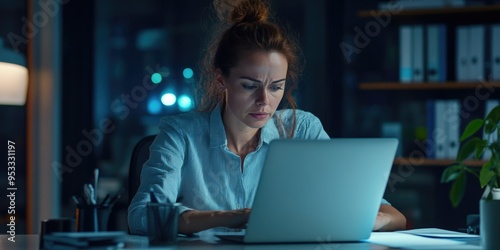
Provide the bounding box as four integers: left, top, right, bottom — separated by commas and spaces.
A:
479, 199, 500, 250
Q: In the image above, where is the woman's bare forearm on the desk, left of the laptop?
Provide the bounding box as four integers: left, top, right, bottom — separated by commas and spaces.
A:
178, 208, 250, 234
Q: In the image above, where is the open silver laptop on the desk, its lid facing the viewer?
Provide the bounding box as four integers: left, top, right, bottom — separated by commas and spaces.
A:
216, 138, 398, 243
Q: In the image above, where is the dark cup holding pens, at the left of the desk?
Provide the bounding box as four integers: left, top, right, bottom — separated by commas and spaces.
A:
75, 205, 112, 232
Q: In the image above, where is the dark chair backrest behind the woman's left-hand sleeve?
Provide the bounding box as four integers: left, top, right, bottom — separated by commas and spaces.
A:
128, 135, 156, 204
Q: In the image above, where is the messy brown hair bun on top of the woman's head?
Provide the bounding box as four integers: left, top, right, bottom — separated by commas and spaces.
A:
214, 0, 269, 24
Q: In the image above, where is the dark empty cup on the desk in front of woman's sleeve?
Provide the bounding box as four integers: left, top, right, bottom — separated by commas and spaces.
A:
146, 203, 180, 245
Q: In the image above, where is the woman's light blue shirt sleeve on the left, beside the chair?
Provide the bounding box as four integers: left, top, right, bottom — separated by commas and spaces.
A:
128, 118, 190, 235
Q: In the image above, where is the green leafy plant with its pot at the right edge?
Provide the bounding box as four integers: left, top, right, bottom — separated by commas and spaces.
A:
441, 106, 500, 249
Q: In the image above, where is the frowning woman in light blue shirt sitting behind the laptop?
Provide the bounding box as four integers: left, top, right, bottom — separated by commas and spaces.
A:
128, 0, 406, 234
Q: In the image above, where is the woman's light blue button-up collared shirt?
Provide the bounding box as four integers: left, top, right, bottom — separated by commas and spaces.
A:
128, 107, 384, 234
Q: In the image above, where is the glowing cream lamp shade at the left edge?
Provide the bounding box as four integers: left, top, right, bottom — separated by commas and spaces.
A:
0, 39, 28, 105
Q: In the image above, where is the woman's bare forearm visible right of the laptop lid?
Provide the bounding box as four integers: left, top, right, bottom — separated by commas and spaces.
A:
373, 205, 406, 231
